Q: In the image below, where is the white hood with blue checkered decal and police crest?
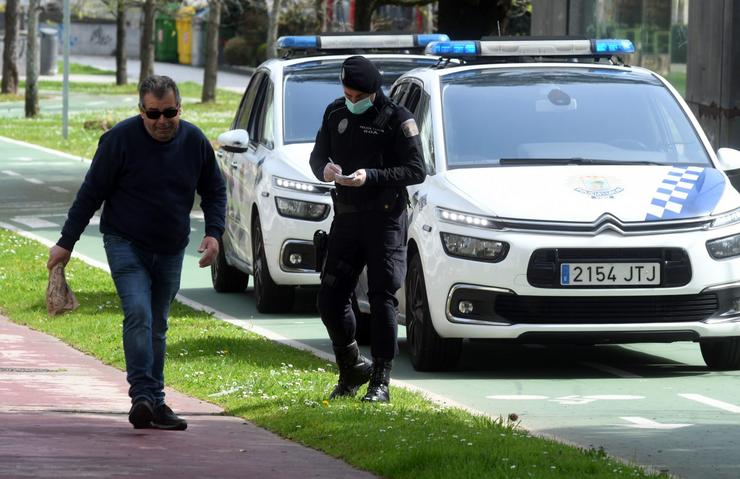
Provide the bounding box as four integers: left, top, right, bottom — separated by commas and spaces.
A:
437, 165, 738, 222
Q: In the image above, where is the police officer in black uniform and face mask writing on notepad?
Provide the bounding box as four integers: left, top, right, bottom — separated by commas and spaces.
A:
311, 56, 426, 402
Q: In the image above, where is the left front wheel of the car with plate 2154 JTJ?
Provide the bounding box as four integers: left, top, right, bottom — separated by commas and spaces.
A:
406, 254, 462, 371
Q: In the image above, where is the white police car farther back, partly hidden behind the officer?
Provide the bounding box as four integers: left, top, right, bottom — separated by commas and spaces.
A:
211, 31, 447, 313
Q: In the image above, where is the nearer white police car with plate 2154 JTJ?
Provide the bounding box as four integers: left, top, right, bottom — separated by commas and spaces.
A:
357, 39, 740, 370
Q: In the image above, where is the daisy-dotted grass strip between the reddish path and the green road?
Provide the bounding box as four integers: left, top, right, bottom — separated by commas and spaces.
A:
0, 230, 665, 479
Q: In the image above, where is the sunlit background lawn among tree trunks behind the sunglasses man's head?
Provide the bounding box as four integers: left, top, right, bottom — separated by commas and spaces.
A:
0, 81, 241, 158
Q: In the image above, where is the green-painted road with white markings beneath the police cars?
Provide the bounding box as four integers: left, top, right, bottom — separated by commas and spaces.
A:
0, 138, 740, 479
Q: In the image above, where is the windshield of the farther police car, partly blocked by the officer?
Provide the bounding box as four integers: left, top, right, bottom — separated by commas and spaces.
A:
283, 57, 437, 144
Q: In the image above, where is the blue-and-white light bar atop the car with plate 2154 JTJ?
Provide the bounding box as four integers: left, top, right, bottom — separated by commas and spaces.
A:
425, 39, 635, 58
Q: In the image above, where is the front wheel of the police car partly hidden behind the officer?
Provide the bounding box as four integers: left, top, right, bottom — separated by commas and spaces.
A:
252, 218, 295, 313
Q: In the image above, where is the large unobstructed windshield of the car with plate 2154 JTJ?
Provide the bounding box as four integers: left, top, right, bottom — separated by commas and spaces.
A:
441, 68, 711, 168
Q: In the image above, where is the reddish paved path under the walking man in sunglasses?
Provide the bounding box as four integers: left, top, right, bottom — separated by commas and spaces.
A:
0, 316, 373, 479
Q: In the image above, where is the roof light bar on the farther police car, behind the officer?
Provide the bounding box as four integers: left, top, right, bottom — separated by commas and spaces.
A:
277, 33, 450, 50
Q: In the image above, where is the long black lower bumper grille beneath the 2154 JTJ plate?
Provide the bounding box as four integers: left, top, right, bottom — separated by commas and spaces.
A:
495, 293, 719, 324
